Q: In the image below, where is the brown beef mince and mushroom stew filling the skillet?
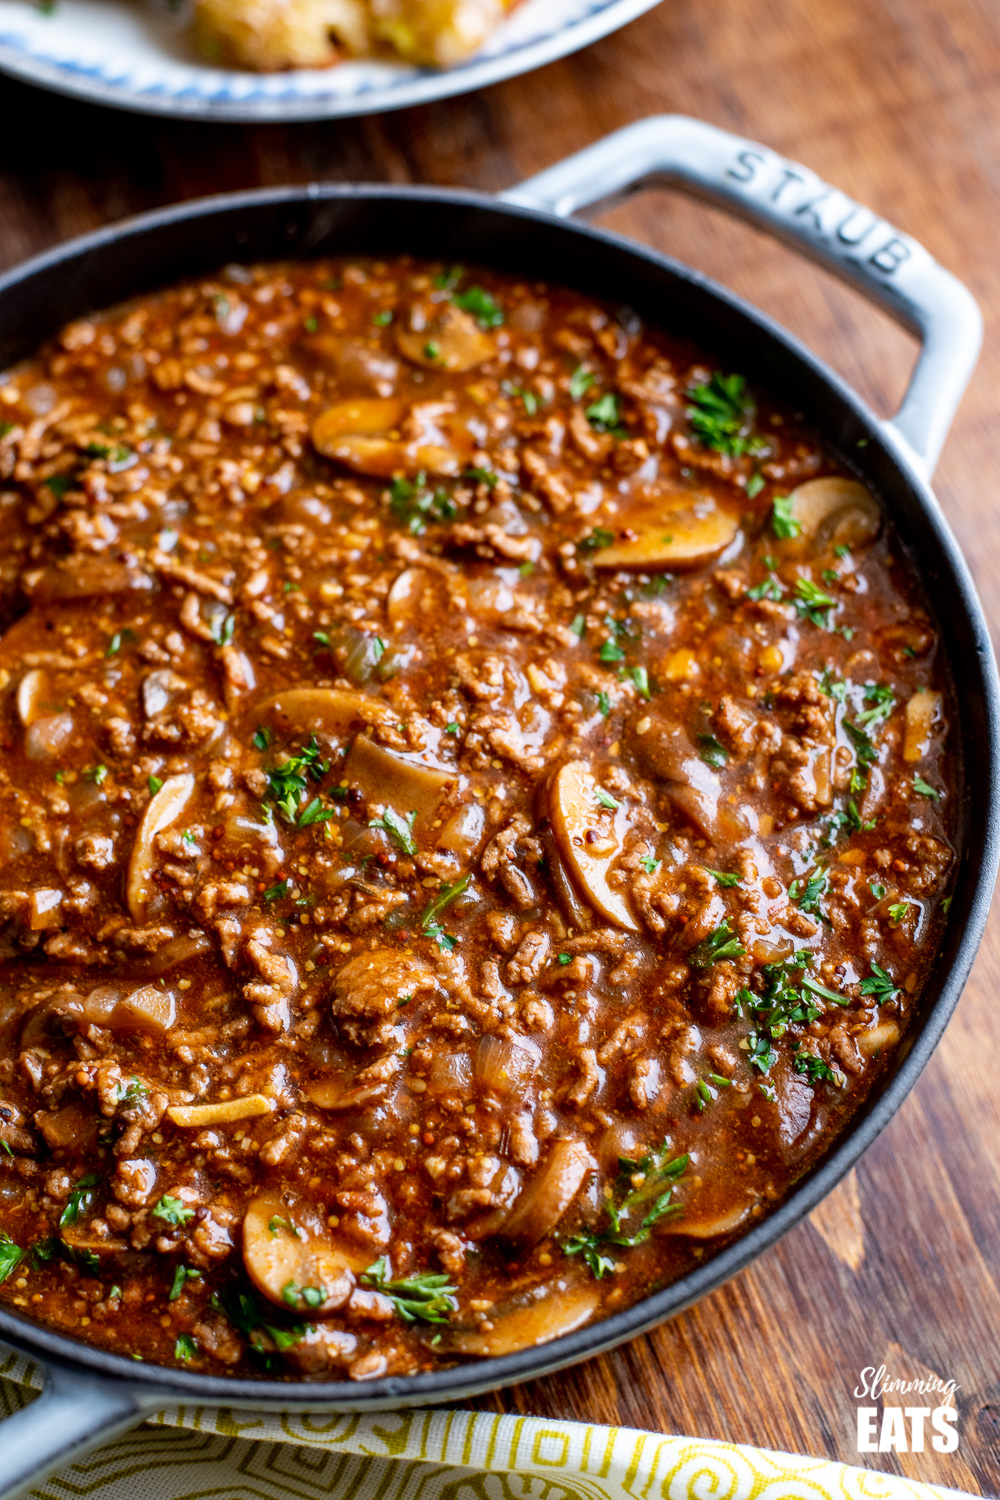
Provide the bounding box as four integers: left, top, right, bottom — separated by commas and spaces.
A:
0, 260, 957, 1380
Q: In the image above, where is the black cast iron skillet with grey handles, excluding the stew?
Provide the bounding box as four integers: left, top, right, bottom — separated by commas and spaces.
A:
0, 116, 1000, 1494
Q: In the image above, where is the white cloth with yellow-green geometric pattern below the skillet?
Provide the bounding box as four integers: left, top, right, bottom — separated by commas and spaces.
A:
0, 1347, 957, 1500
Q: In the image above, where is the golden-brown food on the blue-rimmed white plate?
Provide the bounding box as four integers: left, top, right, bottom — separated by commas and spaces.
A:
193, 0, 527, 72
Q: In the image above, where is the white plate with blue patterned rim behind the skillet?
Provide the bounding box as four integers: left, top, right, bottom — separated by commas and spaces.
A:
0, 0, 658, 120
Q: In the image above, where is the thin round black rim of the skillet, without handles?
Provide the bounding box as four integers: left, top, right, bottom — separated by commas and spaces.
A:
0, 183, 1000, 1413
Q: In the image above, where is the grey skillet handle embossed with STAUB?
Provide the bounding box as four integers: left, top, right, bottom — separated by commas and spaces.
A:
499, 114, 982, 477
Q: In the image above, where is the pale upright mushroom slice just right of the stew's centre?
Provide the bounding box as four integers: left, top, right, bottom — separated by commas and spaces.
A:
552, 761, 639, 932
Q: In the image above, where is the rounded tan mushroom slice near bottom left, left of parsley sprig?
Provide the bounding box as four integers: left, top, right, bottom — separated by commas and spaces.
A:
243, 1191, 370, 1317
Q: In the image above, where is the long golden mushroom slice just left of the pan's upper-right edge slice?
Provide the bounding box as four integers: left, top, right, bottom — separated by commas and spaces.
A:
594, 485, 739, 573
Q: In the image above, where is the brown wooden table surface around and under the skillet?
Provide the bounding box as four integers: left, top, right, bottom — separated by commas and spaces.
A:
0, 0, 1000, 1496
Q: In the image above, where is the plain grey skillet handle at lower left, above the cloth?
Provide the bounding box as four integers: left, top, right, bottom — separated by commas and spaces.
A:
0, 1361, 152, 1500
